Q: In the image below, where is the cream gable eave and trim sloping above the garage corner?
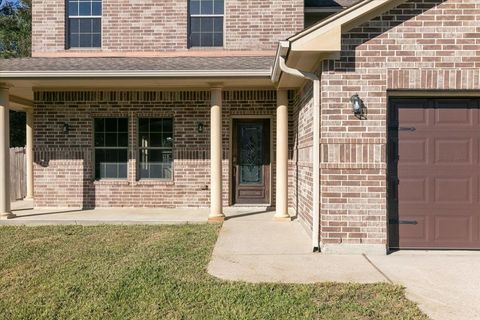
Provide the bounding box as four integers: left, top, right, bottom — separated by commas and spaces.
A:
271, 0, 407, 83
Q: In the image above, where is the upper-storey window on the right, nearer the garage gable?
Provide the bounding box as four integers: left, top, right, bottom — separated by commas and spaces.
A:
188, 0, 224, 47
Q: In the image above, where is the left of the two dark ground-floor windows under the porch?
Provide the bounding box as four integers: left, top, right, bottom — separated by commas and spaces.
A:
94, 118, 128, 179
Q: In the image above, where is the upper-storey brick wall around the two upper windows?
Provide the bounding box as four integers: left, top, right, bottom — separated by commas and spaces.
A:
32, 0, 304, 56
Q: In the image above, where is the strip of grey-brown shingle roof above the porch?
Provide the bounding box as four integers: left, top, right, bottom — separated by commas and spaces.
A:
0, 56, 274, 72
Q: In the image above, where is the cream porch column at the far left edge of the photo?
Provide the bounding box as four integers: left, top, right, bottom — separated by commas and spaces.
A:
0, 83, 15, 219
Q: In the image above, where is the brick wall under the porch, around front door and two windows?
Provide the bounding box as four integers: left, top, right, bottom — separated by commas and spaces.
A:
34, 90, 296, 207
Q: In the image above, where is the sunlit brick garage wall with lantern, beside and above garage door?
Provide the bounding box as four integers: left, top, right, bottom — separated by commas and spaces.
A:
321, 0, 480, 251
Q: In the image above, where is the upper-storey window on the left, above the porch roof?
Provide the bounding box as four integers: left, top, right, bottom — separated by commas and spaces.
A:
67, 0, 102, 48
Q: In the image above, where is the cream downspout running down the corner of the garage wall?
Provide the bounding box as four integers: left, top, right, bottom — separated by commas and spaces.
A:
278, 50, 321, 251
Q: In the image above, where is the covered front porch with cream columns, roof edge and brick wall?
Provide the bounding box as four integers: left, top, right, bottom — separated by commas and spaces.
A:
0, 56, 292, 225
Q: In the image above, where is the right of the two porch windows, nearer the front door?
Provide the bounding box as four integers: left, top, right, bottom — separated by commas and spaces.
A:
138, 118, 173, 179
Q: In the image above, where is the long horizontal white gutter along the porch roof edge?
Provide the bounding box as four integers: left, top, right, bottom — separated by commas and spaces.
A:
0, 70, 271, 78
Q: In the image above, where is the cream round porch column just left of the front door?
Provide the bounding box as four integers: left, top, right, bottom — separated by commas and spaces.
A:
208, 87, 225, 221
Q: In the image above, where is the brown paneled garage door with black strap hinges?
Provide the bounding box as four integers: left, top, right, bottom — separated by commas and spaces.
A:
388, 99, 480, 249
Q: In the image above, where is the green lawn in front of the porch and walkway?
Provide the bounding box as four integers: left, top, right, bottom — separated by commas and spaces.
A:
0, 225, 426, 320
